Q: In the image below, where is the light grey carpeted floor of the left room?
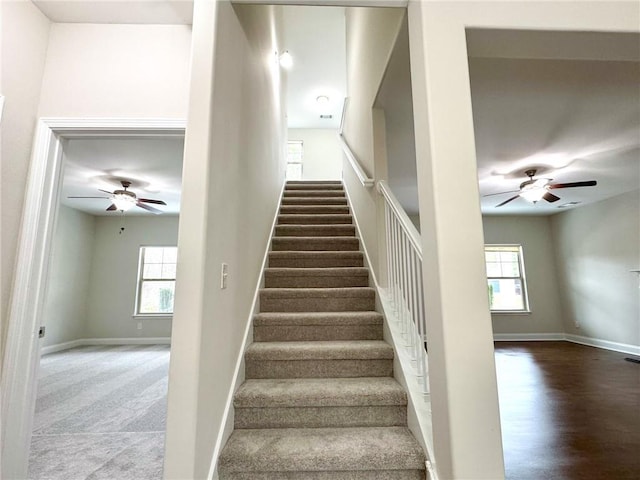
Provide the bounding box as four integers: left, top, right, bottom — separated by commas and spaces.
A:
29, 345, 169, 480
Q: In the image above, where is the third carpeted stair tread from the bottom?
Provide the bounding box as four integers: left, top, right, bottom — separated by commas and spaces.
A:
245, 340, 393, 361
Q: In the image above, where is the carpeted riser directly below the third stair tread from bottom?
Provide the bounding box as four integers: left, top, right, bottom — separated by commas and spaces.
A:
245, 359, 393, 378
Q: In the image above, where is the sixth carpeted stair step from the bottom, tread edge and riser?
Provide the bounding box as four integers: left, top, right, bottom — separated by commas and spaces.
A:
264, 267, 369, 288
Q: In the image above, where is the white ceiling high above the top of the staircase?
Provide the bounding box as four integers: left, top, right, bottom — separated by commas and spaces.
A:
283, 6, 347, 128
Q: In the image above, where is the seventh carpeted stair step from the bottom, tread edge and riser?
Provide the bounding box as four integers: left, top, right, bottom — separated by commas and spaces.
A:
269, 250, 364, 268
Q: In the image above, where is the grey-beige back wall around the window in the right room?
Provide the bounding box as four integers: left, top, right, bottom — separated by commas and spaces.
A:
482, 216, 564, 334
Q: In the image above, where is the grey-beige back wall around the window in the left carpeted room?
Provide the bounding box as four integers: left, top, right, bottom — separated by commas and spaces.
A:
85, 215, 178, 338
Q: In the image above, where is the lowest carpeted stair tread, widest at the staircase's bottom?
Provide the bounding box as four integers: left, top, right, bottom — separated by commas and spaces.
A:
219, 427, 425, 472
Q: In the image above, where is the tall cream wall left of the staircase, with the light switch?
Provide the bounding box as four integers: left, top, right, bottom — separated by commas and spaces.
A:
164, 1, 286, 479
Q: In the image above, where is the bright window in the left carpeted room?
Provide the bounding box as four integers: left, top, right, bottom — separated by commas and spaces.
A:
136, 247, 178, 316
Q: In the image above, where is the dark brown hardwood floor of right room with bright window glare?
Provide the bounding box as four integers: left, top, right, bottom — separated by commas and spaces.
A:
495, 342, 640, 480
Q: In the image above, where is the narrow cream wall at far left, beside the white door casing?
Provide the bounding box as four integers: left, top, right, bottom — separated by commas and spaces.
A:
0, 1, 50, 358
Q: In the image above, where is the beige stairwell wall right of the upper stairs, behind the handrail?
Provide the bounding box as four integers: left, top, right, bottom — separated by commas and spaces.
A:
343, 8, 405, 276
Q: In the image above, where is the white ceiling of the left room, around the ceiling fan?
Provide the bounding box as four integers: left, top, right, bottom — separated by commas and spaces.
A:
60, 138, 184, 216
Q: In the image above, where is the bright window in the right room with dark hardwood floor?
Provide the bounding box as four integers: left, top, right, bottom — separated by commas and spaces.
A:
484, 245, 529, 312
